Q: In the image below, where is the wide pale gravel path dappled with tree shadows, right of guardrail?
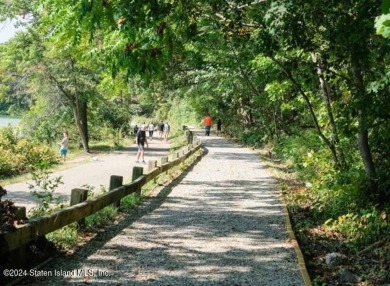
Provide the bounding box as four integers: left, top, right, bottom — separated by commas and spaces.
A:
19, 130, 305, 286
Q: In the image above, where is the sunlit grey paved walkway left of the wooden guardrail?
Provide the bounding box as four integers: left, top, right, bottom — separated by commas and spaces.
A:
3, 135, 169, 212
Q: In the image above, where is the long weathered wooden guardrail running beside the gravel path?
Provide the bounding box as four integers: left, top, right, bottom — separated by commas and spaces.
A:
0, 135, 200, 254
